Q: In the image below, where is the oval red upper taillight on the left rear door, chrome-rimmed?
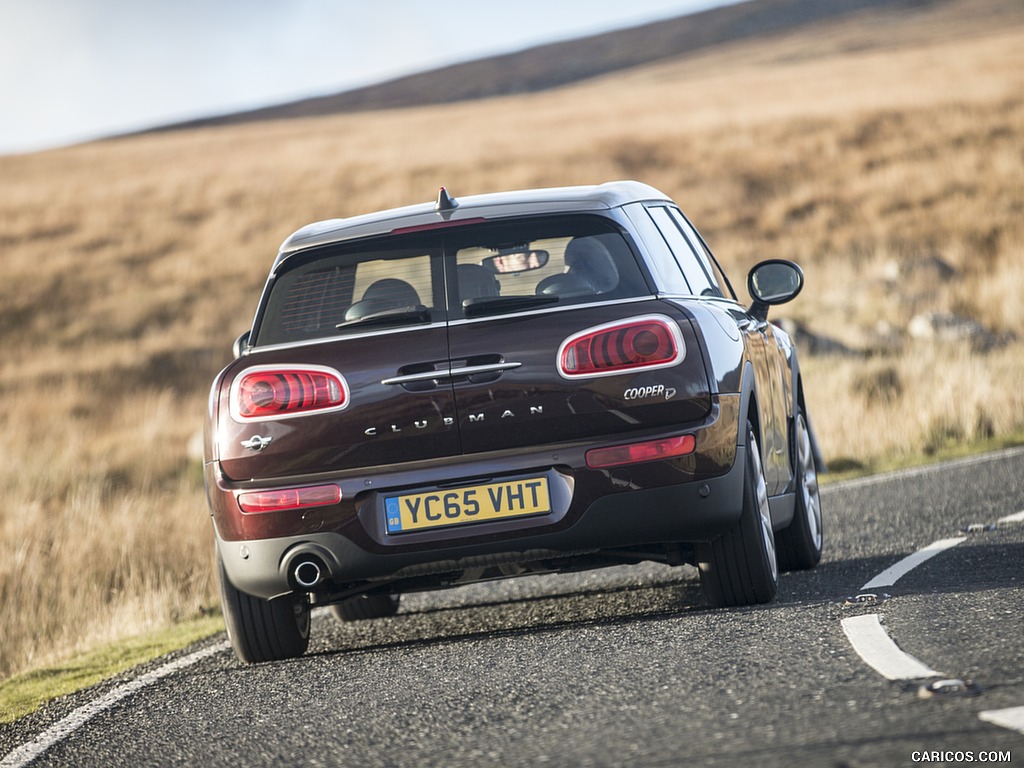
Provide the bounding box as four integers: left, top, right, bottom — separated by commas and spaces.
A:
231, 366, 348, 421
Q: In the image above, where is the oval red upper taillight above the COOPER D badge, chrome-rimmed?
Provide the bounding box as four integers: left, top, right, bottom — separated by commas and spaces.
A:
558, 314, 686, 379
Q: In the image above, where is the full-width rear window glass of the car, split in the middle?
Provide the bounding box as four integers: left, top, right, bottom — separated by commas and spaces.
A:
256, 215, 650, 346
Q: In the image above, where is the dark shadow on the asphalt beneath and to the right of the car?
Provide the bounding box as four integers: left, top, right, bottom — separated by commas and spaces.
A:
299, 544, 1024, 656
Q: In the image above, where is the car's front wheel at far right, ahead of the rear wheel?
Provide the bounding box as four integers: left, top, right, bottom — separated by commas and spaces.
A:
776, 404, 823, 570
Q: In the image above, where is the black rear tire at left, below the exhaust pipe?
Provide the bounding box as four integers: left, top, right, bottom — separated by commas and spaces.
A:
217, 551, 310, 664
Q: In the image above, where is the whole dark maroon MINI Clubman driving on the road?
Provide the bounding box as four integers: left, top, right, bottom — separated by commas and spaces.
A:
205, 181, 821, 662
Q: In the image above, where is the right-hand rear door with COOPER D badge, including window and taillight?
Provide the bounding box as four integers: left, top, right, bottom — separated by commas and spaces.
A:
446, 215, 711, 454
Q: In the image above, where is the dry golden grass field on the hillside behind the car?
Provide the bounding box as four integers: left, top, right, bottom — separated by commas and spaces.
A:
0, 2, 1024, 680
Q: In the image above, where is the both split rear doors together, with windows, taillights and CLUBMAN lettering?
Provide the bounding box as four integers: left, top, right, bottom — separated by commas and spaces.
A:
217, 214, 711, 480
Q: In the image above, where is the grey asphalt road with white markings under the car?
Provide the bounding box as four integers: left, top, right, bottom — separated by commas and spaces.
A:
0, 450, 1024, 768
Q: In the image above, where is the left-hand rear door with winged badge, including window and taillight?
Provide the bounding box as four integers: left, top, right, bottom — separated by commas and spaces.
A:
218, 236, 461, 480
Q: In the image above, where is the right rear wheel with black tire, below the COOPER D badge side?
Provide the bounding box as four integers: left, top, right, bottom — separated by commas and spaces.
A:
696, 423, 778, 607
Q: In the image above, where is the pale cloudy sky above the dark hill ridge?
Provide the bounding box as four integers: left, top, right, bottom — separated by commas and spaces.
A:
0, 0, 737, 155
